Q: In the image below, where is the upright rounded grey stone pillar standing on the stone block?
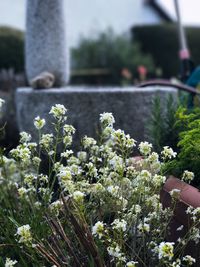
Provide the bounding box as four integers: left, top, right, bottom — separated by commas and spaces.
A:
25, 0, 69, 87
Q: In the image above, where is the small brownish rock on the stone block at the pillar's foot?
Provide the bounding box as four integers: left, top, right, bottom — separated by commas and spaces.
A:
30, 71, 55, 89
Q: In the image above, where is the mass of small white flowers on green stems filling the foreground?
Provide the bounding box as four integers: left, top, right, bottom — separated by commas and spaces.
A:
0, 101, 200, 267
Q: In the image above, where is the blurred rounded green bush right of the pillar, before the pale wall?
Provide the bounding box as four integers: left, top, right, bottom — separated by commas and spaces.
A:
72, 30, 154, 84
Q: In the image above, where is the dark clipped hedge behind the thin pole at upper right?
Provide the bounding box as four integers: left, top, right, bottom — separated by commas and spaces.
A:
132, 24, 200, 78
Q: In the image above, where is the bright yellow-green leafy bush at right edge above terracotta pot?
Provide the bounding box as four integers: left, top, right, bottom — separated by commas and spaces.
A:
166, 108, 200, 187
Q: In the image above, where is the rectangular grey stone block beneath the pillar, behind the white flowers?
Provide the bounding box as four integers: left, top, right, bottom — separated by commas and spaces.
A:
16, 86, 177, 148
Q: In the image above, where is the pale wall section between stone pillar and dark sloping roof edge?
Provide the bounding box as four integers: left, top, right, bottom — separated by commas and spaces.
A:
66, 0, 160, 46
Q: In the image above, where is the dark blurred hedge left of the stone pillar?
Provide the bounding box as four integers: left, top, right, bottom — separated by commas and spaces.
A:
0, 27, 24, 72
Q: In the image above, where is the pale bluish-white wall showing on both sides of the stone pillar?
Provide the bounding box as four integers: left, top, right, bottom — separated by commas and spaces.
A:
0, 0, 164, 46
